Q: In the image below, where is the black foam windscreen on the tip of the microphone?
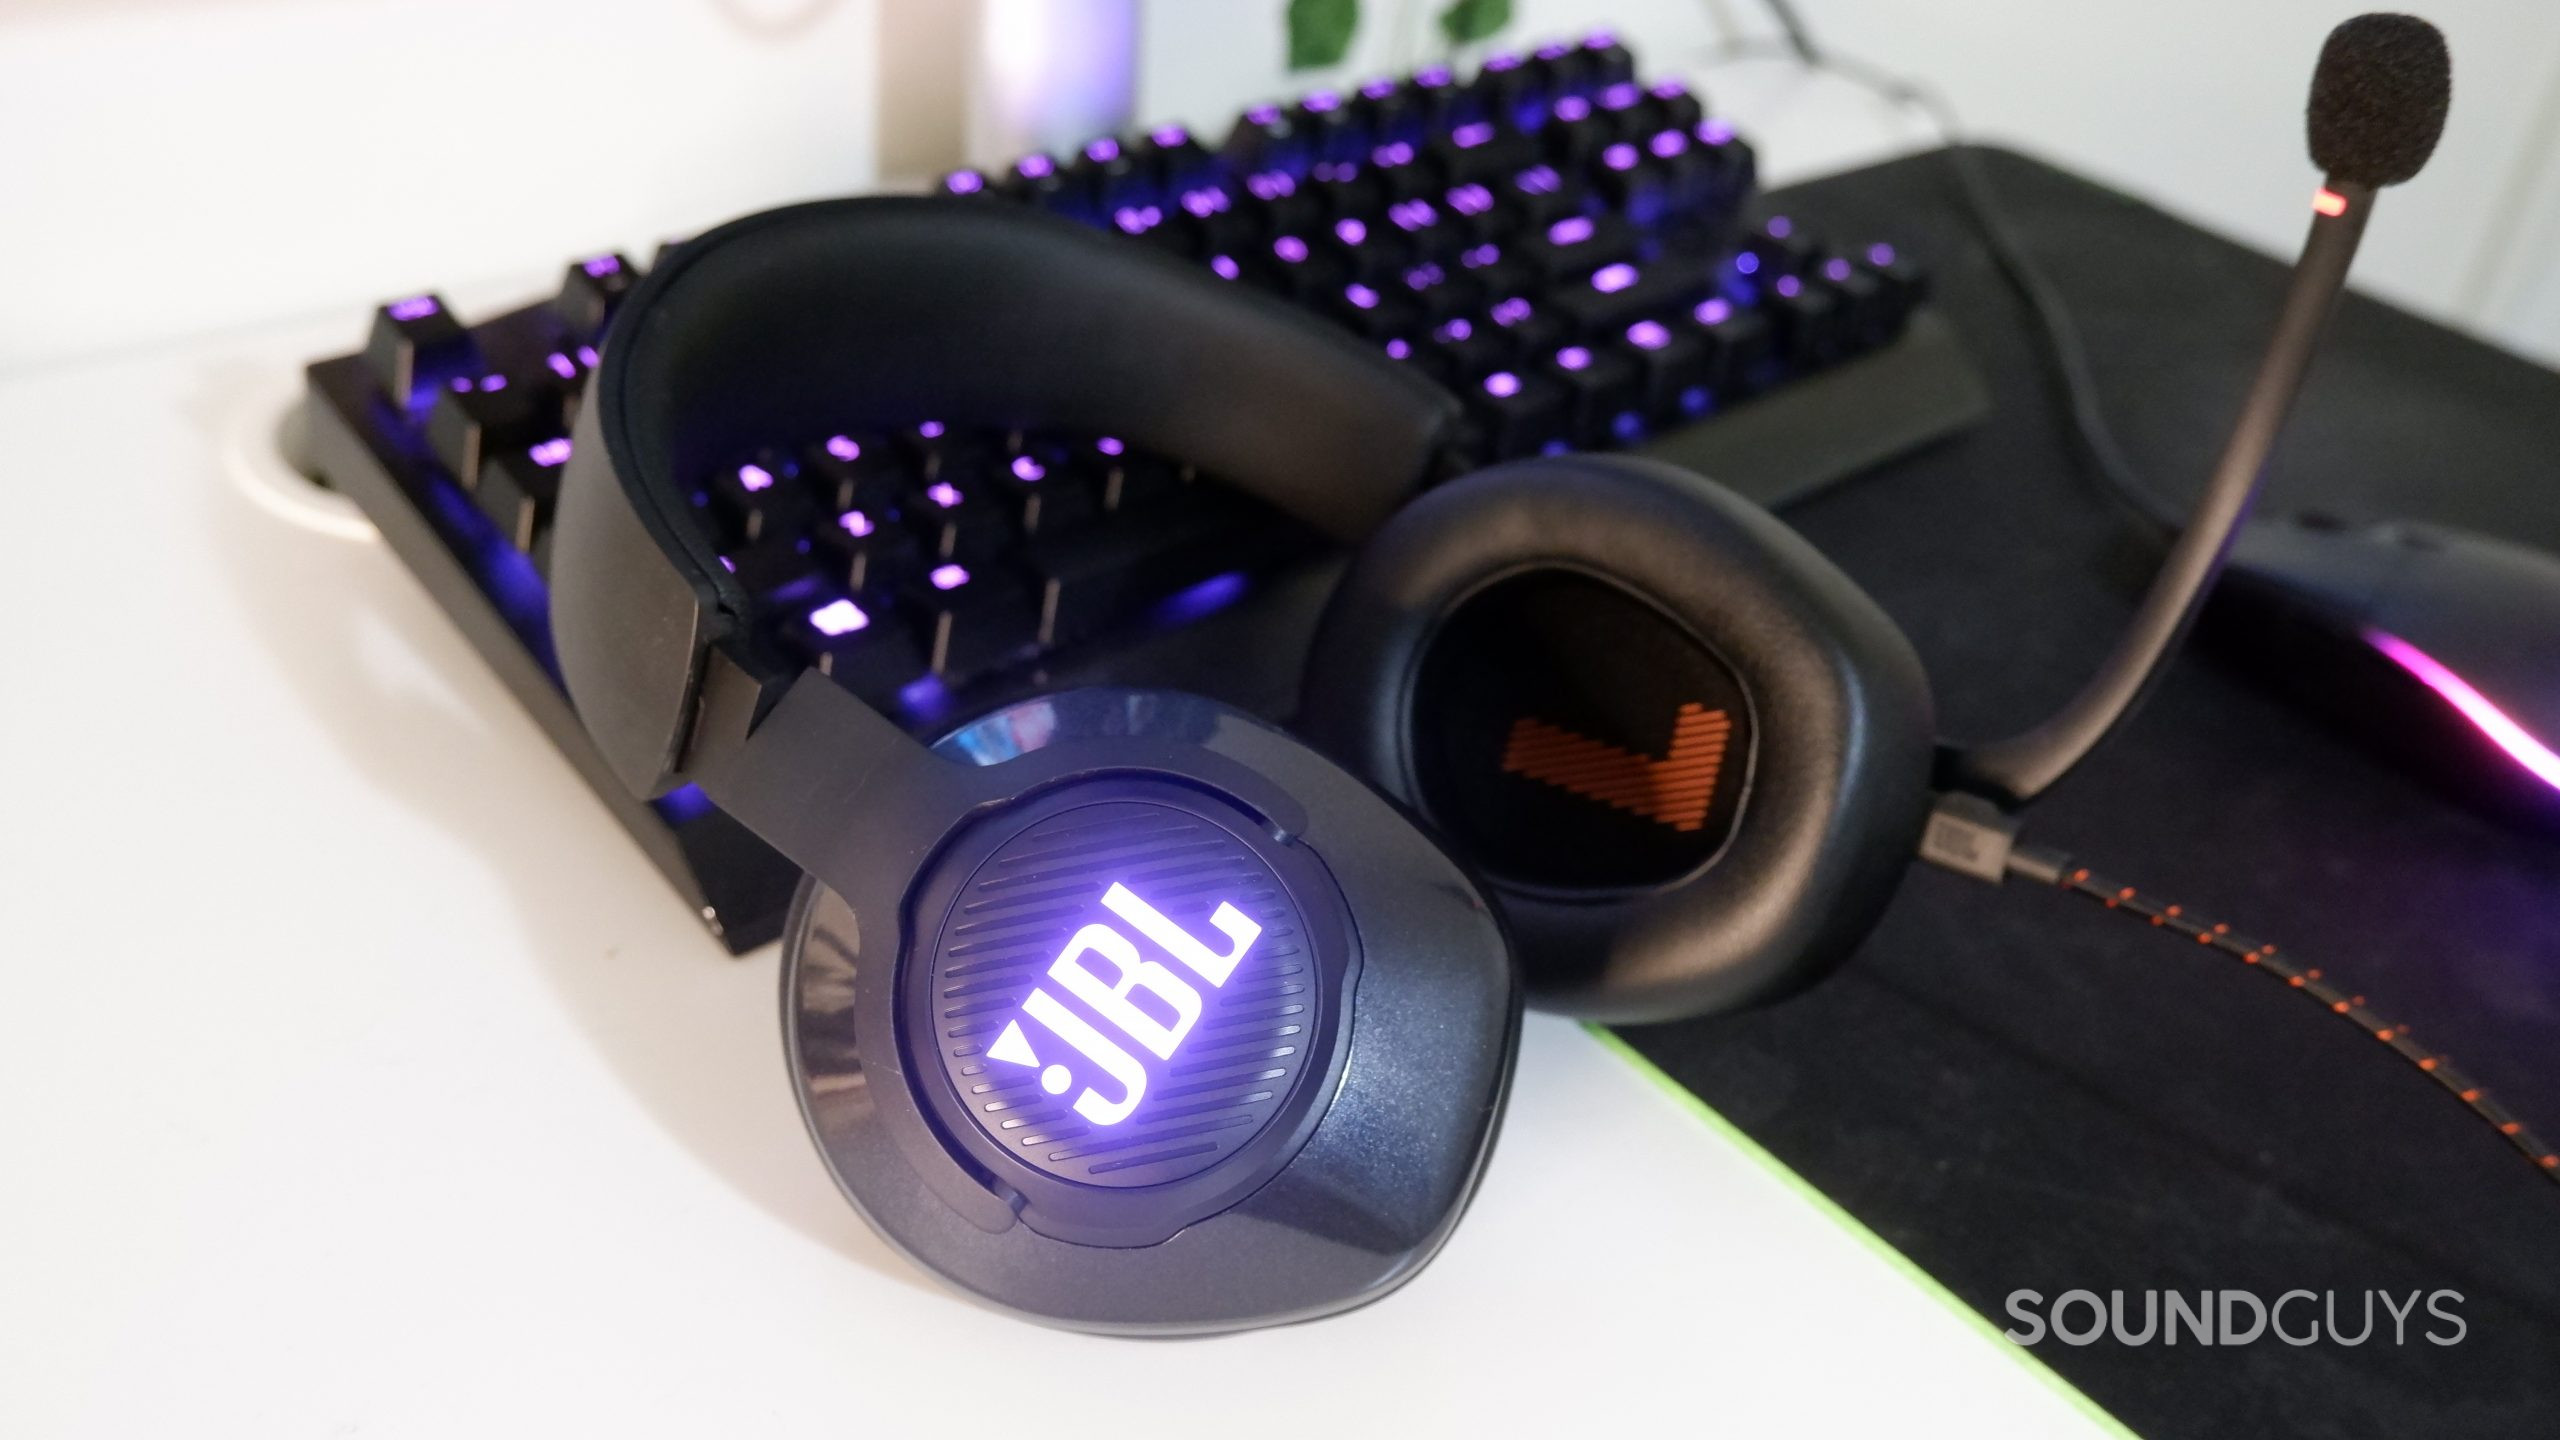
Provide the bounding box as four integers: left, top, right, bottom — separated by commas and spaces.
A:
2309, 15, 2452, 187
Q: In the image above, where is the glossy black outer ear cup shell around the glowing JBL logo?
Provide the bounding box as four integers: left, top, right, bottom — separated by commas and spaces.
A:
783, 692, 1521, 1332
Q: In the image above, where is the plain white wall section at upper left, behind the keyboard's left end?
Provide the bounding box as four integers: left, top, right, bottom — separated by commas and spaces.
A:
0, 0, 876, 374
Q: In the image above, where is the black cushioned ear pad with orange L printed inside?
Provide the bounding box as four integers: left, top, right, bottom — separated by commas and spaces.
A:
1300, 456, 1933, 1022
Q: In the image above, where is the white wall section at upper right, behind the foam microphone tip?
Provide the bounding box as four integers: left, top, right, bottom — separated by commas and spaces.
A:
1139, 0, 2560, 364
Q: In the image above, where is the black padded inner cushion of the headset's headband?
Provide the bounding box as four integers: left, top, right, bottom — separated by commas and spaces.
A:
596, 197, 1457, 607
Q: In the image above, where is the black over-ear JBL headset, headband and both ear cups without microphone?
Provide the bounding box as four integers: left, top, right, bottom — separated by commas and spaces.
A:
553, 200, 1933, 1332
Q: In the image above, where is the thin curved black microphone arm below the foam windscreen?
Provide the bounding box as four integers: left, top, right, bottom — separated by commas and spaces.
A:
1946, 174, 2373, 810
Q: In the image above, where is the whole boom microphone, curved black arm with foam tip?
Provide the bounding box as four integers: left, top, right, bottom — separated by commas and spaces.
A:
1948, 15, 2452, 810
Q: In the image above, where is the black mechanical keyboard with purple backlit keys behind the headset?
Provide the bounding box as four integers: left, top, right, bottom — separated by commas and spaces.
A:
294, 36, 1984, 951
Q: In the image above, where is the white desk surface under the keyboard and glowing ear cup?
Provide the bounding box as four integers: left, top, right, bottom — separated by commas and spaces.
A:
0, 308, 2107, 1440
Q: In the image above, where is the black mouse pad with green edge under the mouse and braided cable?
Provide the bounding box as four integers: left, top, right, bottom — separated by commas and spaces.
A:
1620, 151, 2560, 1440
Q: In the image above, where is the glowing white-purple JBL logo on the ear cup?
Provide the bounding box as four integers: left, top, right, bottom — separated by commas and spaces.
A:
986, 884, 1262, 1125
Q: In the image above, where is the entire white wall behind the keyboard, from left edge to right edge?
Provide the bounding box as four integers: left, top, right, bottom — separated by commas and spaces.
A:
0, 0, 2560, 374
